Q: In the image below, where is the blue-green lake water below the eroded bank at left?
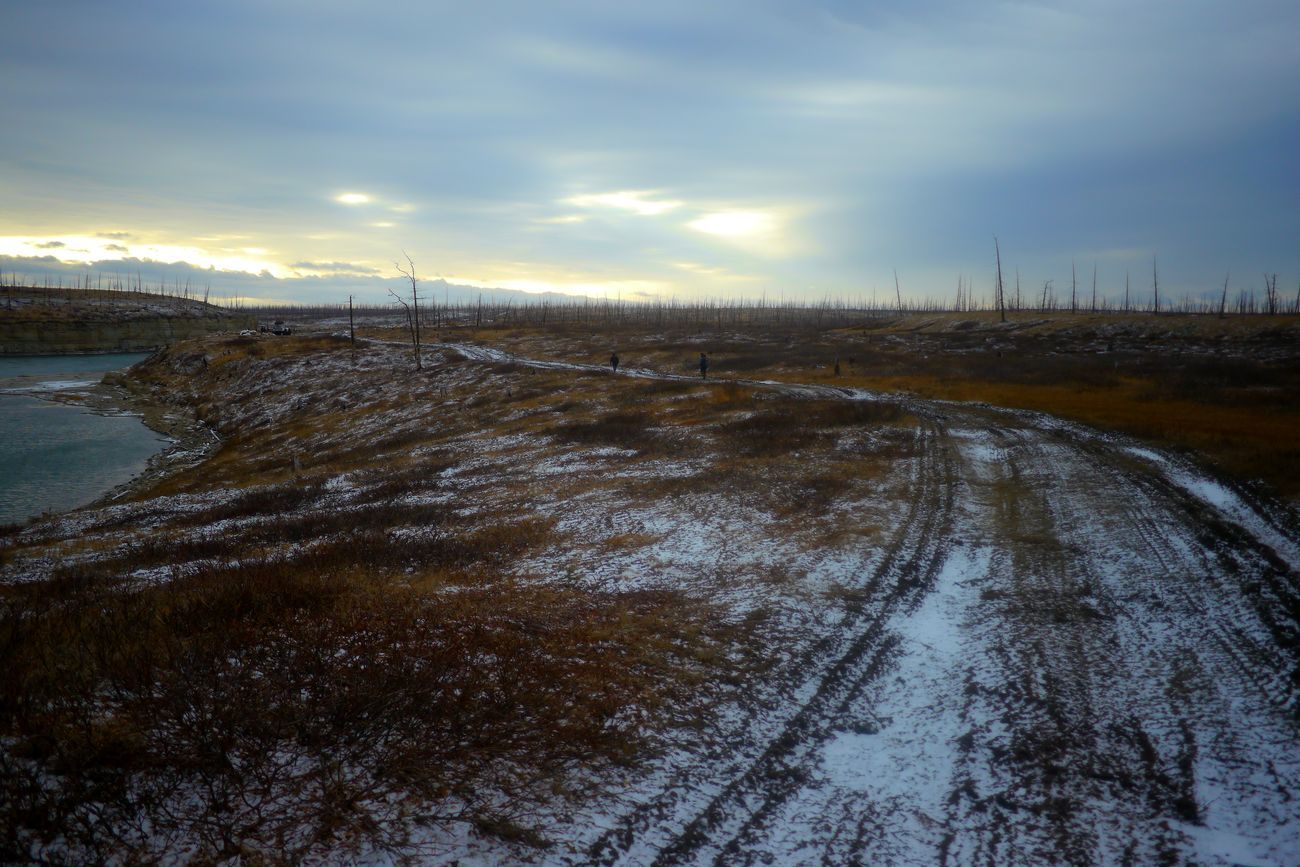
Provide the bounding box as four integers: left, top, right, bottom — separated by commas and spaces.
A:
0, 352, 168, 524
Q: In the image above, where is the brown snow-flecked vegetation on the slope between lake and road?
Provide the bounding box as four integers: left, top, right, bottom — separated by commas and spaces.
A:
0, 327, 925, 861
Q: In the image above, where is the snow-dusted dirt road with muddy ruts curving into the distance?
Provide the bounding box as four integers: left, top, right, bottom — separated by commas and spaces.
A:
442, 346, 1300, 864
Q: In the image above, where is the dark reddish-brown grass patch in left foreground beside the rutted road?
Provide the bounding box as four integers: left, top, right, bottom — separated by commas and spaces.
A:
0, 528, 722, 861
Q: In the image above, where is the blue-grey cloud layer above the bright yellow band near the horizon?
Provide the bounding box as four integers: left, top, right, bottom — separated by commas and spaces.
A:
0, 0, 1300, 301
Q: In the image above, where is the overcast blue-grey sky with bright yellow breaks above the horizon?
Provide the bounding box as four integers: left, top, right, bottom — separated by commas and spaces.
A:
0, 0, 1300, 303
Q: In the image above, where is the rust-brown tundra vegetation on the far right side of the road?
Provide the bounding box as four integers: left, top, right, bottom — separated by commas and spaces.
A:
456, 311, 1300, 502
